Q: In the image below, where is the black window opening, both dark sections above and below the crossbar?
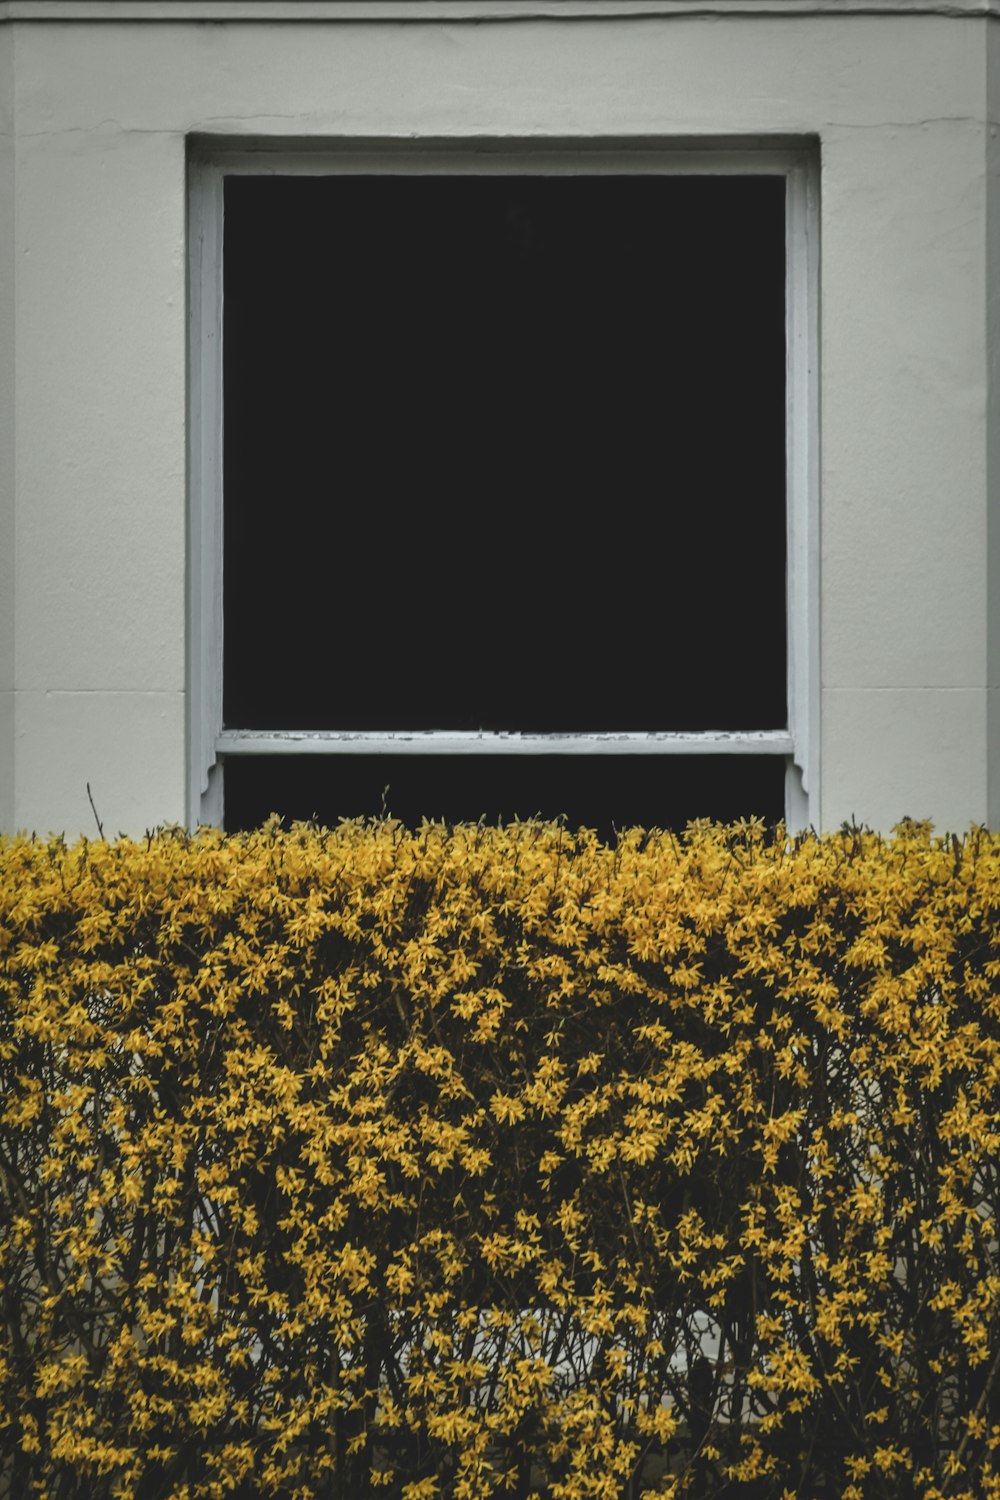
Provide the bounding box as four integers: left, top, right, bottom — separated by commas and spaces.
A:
223, 173, 787, 831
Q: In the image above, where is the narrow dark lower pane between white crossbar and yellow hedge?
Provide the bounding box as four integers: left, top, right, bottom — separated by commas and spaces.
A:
225, 755, 784, 839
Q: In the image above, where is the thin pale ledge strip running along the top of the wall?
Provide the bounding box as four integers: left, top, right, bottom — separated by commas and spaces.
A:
0, 0, 1000, 24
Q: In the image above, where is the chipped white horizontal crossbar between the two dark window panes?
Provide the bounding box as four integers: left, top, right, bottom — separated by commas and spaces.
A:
216, 729, 795, 756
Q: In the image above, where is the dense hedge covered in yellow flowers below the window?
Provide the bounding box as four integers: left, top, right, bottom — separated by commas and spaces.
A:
0, 822, 1000, 1500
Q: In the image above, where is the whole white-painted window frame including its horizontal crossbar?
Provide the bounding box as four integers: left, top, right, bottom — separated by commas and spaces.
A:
187, 140, 820, 831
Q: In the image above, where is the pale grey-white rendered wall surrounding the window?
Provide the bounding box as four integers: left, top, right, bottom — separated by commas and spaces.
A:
0, 6, 1000, 833
